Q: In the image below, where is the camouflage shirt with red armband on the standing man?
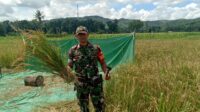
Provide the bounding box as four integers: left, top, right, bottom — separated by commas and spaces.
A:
68, 42, 104, 78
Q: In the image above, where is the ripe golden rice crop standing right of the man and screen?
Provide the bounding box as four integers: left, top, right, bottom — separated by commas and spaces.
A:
105, 39, 200, 112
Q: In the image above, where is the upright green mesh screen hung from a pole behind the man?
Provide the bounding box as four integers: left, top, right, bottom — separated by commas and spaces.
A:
27, 35, 135, 72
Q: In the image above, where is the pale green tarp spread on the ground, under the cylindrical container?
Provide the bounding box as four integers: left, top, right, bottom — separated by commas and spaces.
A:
0, 71, 76, 112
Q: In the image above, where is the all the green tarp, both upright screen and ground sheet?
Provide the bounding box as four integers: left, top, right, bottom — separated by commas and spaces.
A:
0, 35, 135, 112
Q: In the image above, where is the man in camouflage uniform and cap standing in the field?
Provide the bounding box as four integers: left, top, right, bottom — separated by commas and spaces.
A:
68, 26, 110, 112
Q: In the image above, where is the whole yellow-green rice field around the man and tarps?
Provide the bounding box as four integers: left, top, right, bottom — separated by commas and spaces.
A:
0, 32, 200, 112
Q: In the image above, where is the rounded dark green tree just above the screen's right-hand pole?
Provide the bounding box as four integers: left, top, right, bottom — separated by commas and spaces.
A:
128, 20, 143, 32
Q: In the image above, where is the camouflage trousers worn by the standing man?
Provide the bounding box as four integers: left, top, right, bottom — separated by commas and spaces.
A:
75, 75, 105, 112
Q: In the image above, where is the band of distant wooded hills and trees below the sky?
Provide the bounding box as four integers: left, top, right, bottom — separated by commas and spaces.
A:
0, 11, 200, 36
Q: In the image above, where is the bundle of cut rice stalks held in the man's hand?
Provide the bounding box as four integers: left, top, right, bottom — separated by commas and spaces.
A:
22, 31, 74, 82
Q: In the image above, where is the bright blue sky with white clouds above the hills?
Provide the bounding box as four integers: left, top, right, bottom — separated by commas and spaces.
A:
0, 0, 200, 21
